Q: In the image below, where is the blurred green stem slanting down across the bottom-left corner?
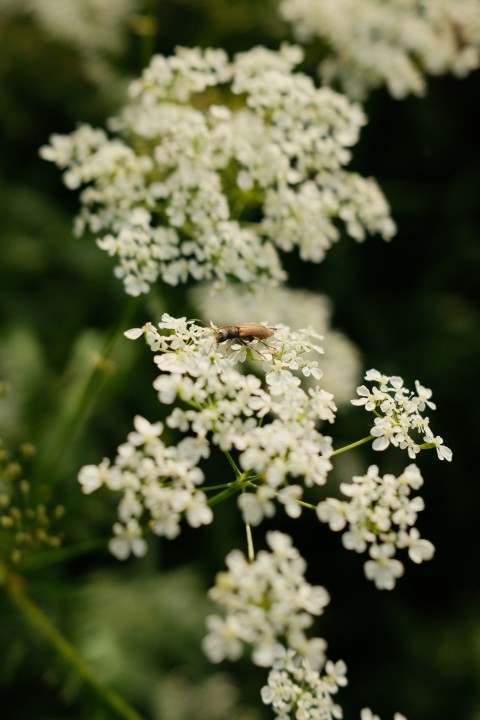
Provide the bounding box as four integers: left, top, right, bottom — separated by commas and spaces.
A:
7, 575, 142, 720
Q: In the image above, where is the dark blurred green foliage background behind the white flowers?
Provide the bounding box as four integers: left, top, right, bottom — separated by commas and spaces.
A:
0, 0, 480, 720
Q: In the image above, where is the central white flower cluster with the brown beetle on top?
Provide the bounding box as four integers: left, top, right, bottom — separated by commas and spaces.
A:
141, 314, 336, 506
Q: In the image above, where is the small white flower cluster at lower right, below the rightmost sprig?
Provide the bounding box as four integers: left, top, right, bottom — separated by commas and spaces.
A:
317, 465, 435, 590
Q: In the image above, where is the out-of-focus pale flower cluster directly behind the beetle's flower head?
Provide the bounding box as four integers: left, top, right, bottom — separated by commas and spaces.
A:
190, 284, 361, 405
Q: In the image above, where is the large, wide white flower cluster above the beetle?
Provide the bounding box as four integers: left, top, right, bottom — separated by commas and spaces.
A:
41, 46, 395, 295
